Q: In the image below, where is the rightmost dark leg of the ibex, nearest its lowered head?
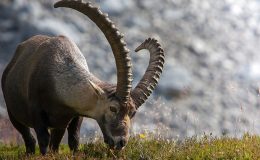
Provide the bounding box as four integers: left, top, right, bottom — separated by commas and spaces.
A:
68, 117, 83, 152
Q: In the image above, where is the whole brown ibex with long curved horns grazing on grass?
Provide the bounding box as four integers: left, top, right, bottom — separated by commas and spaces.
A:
2, 0, 164, 154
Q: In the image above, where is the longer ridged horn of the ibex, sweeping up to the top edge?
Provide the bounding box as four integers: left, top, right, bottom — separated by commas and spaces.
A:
54, 0, 132, 103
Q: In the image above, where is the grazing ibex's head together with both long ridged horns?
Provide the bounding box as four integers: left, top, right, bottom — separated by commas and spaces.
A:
54, 0, 164, 149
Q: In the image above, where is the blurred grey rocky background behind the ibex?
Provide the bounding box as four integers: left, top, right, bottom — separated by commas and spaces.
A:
0, 0, 260, 143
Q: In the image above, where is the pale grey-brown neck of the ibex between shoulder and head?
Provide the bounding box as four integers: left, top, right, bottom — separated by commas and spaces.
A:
55, 66, 105, 117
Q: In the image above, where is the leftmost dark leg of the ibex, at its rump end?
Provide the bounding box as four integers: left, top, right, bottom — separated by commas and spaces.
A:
8, 111, 36, 154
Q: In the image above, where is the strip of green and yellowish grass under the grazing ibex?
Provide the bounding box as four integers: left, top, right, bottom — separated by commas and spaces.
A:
0, 134, 260, 160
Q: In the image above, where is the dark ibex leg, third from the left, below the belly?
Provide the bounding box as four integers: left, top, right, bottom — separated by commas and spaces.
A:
49, 129, 66, 152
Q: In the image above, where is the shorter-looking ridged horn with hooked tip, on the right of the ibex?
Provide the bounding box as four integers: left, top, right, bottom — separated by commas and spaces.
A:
131, 38, 164, 108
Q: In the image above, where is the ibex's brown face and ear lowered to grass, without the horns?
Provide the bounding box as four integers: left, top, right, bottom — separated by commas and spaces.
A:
88, 84, 136, 149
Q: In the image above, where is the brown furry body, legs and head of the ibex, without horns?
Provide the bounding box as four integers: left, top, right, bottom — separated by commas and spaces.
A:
2, 36, 135, 154
